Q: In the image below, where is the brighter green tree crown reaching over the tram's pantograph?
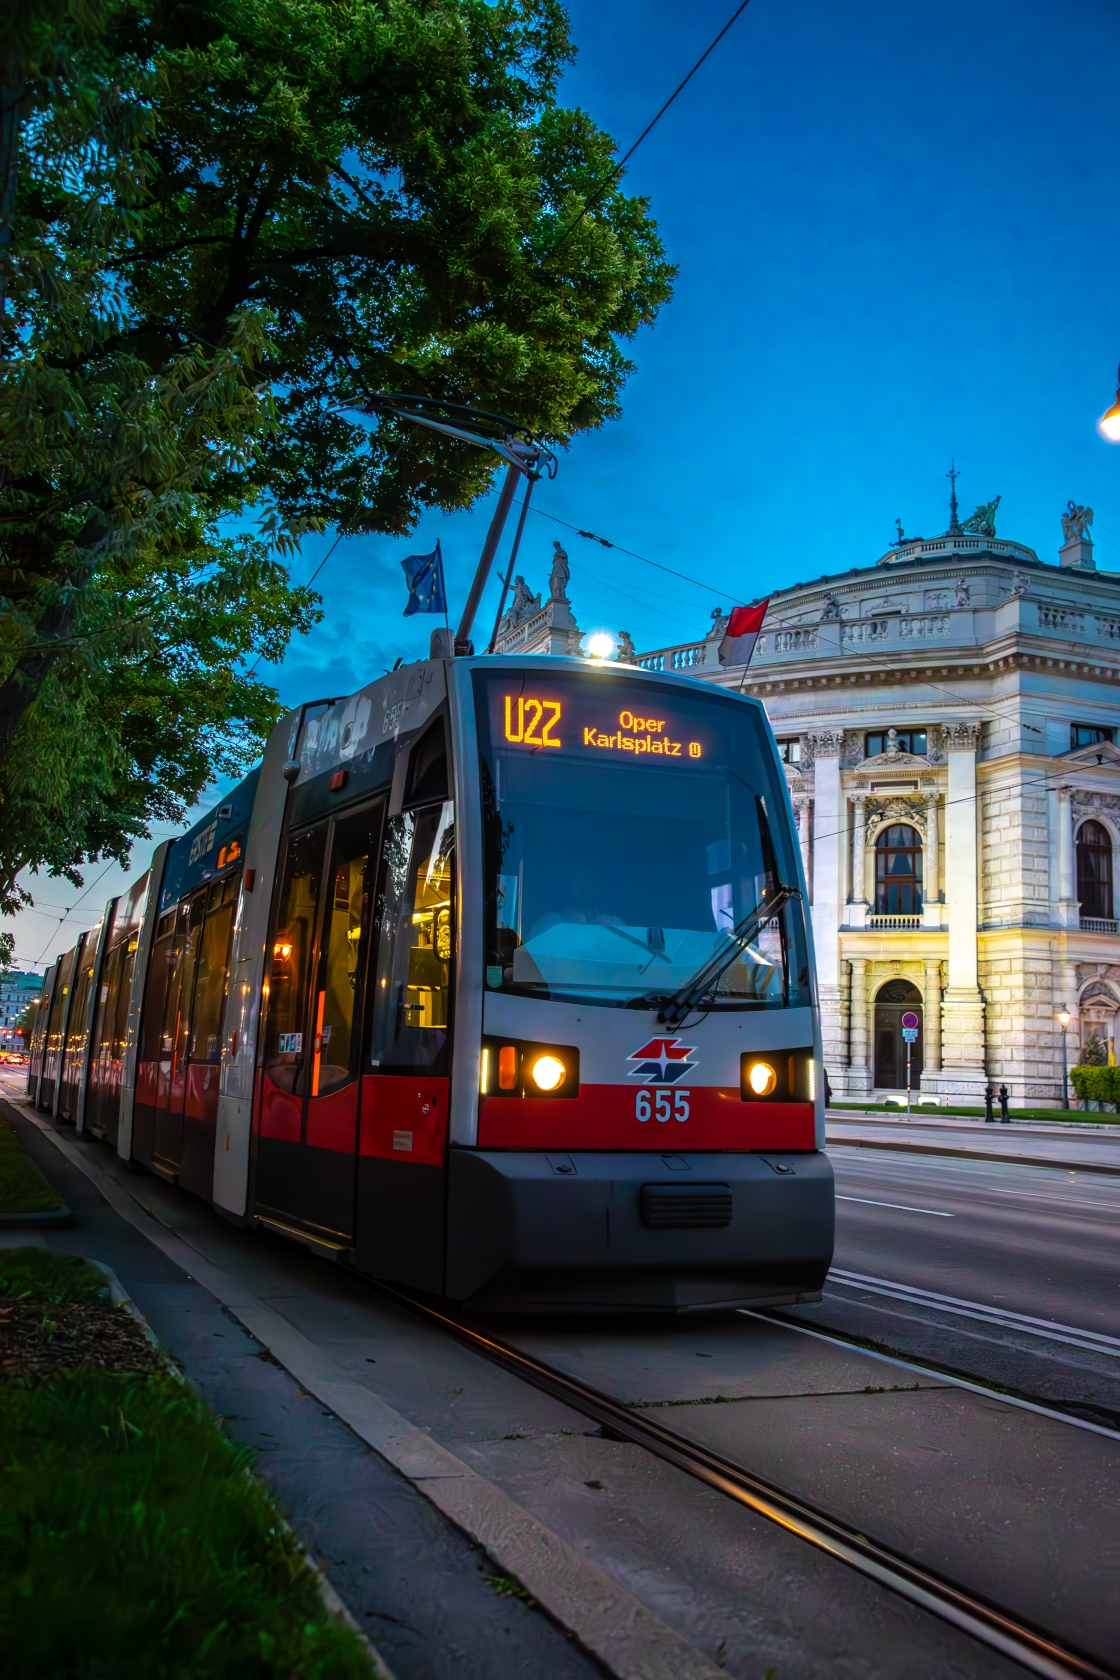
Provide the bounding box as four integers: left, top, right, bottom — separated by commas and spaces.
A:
109, 0, 673, 533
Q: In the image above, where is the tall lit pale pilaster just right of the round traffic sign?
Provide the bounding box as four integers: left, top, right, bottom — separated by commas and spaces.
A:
932, 724, 987, 1100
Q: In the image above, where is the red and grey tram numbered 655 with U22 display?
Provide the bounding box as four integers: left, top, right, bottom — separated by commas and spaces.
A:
29, 657, 833, 1312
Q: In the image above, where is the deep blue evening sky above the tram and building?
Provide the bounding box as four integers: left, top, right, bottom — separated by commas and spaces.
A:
15, 0, 1120, 961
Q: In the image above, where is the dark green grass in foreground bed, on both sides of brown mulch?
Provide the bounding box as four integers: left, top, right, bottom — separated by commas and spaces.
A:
0, 1248, 373, 1680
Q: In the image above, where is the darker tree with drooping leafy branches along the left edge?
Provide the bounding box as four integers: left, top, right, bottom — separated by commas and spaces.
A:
0, 0, 316, 911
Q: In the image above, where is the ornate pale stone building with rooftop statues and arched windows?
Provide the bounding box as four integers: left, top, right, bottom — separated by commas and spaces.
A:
638, 497, 1120, 1104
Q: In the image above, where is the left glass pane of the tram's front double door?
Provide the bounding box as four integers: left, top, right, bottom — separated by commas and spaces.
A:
264, 825, 326, 1090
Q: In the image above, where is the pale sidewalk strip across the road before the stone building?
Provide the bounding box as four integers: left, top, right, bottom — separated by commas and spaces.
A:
826, 1110, 1120, 1176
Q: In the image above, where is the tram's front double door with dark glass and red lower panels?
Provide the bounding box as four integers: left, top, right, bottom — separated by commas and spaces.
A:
255, 800, 385, 1245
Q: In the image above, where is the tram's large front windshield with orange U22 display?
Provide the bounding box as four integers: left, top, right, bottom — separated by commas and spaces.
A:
475, 669, 811, 1010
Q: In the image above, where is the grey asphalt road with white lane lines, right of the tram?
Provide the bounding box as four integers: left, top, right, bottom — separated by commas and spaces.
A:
796, 1139, 1120, 1426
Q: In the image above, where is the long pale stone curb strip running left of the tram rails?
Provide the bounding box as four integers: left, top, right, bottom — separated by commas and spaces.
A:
29, 1116, 727, 1680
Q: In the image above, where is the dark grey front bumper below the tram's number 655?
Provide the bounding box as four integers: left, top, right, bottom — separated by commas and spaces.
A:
445, 1149, 835, 1312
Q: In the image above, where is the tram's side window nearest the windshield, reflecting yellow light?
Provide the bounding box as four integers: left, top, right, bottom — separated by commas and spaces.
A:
369, 800, 455, 1067
